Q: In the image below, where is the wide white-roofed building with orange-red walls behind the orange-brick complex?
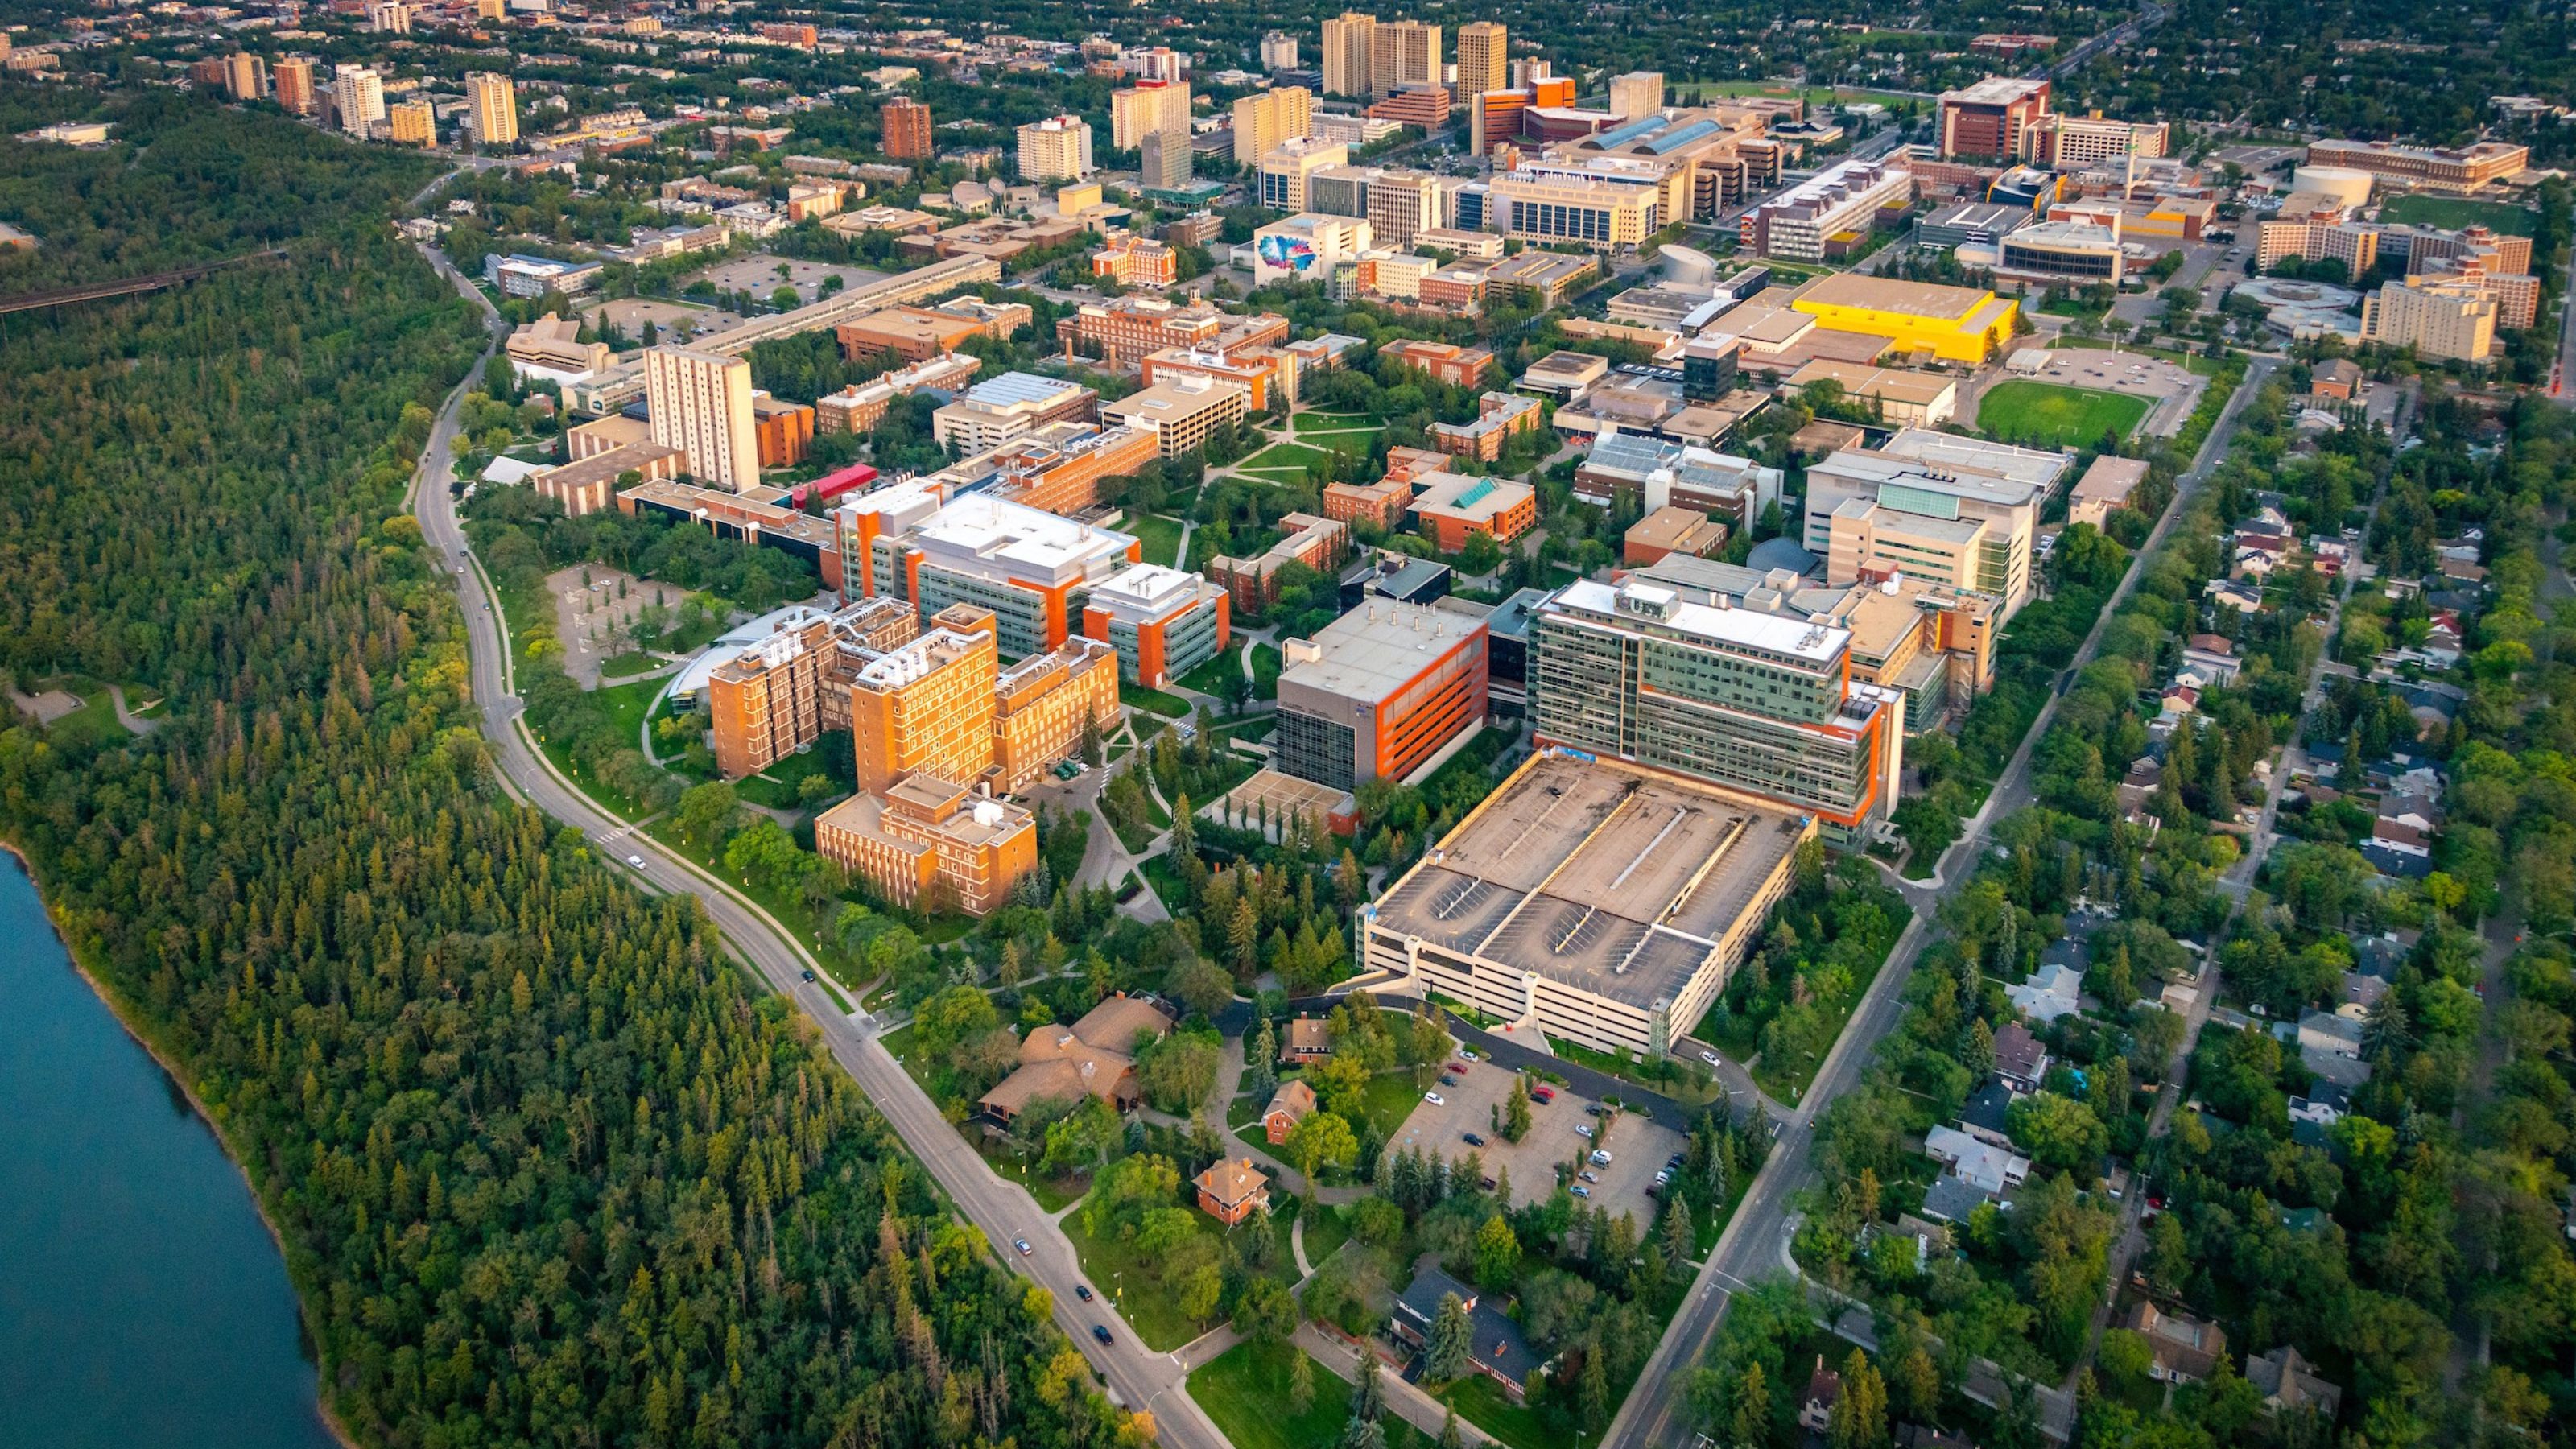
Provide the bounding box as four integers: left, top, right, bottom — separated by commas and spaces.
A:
835, 482, 1144, 660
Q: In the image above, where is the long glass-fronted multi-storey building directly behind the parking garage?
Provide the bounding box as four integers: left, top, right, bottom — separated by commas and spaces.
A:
1530, 580, 1904, 836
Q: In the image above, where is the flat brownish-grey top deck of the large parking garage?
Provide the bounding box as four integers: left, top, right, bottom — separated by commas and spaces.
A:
1376, 753, 1808, 1008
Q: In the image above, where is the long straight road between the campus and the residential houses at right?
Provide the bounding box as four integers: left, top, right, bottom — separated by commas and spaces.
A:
1600, 358, 2277, 1449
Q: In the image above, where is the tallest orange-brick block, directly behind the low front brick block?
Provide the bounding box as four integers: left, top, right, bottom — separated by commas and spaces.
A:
850, 606, 1002, 794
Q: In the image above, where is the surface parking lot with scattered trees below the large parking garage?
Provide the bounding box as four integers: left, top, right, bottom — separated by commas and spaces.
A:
1389, 1036, 1682, 1230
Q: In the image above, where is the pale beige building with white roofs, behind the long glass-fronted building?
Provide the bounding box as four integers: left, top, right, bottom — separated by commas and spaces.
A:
1803, 428, 2074, 611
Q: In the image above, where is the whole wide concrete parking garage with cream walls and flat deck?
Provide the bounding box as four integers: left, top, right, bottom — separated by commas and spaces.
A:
1360, 750, 1816, 1057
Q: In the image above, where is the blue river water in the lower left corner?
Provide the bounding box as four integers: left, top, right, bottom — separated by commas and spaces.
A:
0, 853, 335, 1449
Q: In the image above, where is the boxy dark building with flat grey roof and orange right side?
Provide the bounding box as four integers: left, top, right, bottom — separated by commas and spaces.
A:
1270, 598, 1489, 789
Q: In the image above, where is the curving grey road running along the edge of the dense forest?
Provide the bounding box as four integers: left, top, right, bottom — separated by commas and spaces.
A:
412, 253, 1232, 1449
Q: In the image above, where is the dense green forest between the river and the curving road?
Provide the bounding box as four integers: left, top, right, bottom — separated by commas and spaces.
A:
0, 88, 1149, 1447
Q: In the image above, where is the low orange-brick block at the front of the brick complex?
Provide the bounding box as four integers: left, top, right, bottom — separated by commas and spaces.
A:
814, 774, 1038, 915
